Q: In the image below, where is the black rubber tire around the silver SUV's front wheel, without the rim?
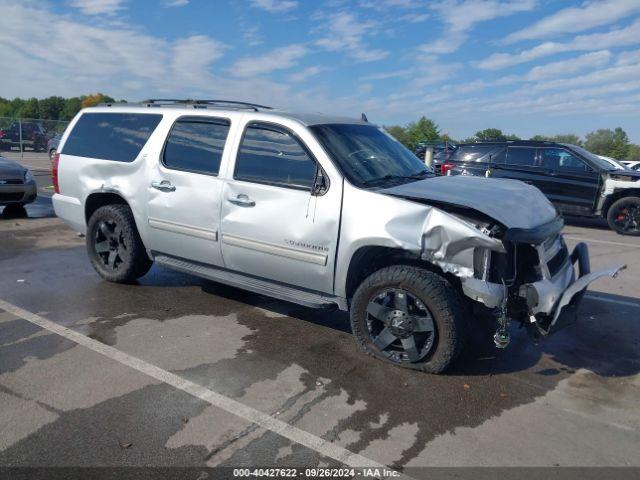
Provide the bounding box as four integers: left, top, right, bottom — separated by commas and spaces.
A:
351, 265, 469, 374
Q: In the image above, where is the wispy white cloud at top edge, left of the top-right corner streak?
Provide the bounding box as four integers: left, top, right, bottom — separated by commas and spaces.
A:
420, 0, 537, 54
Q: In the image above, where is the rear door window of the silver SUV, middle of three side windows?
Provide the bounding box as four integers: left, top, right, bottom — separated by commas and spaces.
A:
163, 118, 230, 175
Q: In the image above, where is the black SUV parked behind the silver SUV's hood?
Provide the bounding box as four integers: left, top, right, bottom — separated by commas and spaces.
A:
438, 140, 640, 235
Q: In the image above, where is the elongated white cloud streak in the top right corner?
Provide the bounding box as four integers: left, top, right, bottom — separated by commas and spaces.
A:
505, 0, 640, 42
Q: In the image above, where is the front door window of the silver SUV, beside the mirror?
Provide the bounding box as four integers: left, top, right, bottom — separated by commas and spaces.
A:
234, 125, 316, 190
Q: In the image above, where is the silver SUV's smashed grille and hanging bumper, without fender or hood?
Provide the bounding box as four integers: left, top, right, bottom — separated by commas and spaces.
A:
444, 217, 625, 348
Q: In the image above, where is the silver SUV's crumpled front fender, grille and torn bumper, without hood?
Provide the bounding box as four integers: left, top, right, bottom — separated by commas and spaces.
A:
412, 204, 625, 348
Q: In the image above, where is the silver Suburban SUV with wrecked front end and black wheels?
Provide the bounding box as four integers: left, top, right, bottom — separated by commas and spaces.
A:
53, 100, 622, 373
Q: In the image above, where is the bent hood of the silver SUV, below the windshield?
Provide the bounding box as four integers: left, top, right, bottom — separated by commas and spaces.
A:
380, 175, 557, 229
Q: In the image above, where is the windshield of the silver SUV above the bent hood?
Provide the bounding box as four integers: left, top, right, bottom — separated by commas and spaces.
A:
310, 124, 431, 187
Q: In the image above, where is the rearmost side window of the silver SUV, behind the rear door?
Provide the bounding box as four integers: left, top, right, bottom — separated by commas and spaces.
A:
61, 113, 162, 162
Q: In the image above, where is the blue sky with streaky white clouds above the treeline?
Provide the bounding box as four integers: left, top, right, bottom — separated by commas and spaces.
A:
0, 0, 640, 143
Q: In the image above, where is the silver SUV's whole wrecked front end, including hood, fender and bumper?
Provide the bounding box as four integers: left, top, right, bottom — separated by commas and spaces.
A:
385, 177, 625, 348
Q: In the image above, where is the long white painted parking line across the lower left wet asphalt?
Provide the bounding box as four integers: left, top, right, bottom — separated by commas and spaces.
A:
0, 300, 400, 479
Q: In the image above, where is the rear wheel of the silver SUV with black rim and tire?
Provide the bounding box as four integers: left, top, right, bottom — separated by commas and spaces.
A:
87, 205, 153, 283
